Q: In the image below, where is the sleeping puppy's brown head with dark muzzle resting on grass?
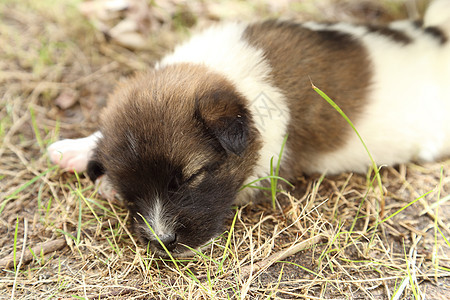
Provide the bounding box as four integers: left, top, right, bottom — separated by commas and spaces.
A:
88, 64, 260, 255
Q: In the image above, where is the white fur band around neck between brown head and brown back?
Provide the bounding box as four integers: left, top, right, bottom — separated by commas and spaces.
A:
157, 23, 290, 203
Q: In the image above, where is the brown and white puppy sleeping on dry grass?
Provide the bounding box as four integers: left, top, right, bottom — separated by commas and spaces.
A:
48, 1, 450, 256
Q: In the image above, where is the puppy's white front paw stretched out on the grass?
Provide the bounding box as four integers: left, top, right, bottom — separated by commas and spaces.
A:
47, 131, 102, 173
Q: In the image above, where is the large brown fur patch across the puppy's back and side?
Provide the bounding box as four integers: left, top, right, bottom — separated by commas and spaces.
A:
245, 21, 371, 177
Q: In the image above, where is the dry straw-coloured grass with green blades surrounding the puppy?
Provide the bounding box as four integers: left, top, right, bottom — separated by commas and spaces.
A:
0, 0, 450, 299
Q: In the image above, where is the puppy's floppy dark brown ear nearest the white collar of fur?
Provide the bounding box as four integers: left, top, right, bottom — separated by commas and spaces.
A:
196, 88, 249, 155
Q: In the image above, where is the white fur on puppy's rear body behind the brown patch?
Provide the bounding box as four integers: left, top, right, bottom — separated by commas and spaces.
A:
300, 18, 450, 173
